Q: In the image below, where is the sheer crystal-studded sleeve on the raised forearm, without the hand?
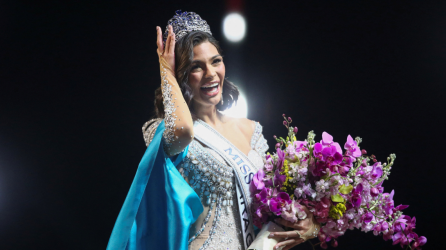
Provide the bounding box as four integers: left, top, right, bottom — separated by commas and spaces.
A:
160, 57, 194, 156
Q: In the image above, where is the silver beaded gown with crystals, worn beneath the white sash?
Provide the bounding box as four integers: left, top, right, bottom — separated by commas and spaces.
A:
143, 118, 268, 250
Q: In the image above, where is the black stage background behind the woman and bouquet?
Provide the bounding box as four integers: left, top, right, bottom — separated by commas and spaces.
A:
0, 0, 446, 249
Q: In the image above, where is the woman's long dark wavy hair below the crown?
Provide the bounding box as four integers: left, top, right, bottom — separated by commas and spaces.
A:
155, 31, 239, 118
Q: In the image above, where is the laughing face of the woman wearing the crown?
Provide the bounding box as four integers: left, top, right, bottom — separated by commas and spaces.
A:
189, 42, 225, 109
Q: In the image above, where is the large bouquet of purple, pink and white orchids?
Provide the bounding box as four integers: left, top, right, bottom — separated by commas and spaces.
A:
250, 115, 427, 249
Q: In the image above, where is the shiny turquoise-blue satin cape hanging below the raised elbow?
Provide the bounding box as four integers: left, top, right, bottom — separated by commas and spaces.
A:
107, 121, 203, 250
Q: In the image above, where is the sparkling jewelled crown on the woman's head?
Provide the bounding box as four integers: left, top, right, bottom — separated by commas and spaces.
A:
163, 10, 212, 43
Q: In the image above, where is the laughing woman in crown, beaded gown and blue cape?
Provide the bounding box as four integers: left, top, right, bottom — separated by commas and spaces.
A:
107, 11, 314, 249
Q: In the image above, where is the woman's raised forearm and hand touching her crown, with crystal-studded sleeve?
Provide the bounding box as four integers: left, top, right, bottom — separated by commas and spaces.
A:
156, 26, 194, 156
